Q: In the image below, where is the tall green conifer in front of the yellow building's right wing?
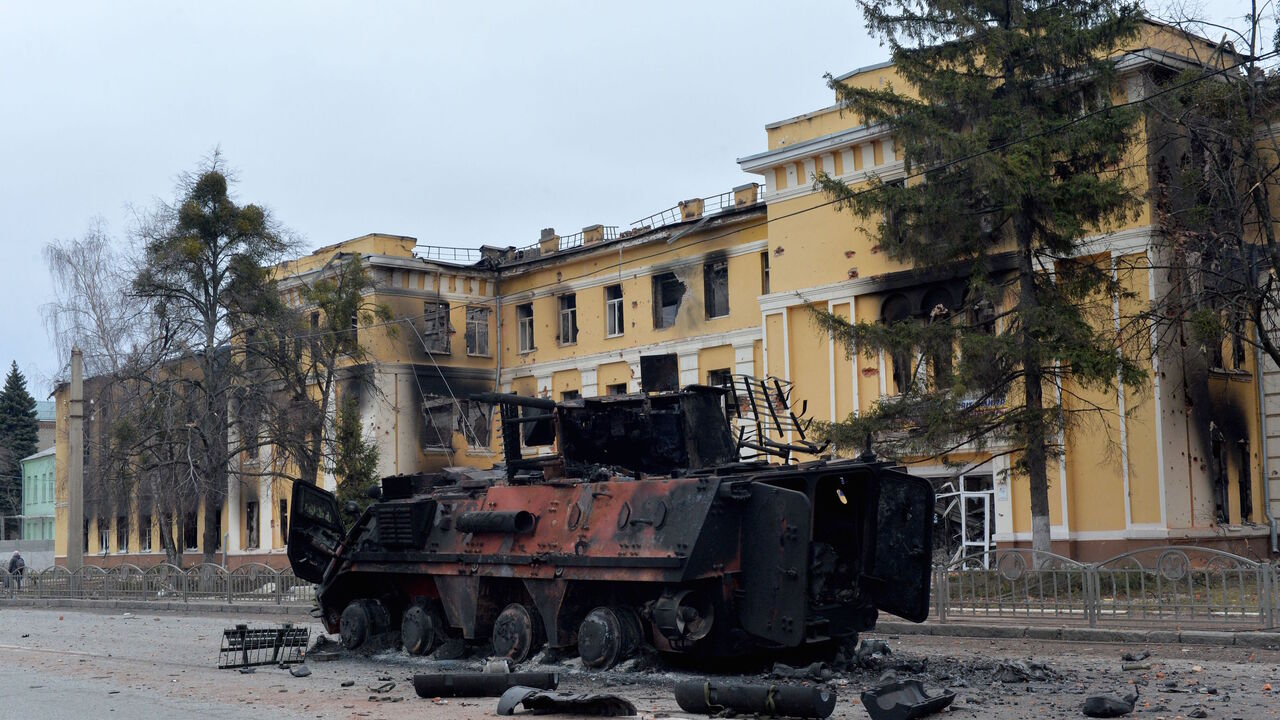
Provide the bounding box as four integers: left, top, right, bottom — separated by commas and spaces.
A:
818, 0, 1144, 551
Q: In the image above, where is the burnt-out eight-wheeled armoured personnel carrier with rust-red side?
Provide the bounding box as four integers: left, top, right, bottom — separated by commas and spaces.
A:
288, 375, 933, 667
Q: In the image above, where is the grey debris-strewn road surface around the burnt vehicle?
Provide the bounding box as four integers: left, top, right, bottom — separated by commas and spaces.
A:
0, 607, 1280, 720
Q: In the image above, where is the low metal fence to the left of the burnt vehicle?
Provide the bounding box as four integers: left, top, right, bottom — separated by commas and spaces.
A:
0, 562, 315, 605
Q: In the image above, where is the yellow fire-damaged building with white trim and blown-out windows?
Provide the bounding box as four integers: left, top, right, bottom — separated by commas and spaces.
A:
55, 19, 1280, 566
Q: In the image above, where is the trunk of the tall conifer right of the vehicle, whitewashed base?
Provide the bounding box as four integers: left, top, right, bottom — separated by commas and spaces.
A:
1014, 213, 1050, 552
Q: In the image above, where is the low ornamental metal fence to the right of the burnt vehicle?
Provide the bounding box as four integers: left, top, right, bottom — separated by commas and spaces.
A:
933, 546, 1280, 629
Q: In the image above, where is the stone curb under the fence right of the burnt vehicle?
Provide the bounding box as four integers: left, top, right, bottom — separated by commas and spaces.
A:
874, 620, 1280, 650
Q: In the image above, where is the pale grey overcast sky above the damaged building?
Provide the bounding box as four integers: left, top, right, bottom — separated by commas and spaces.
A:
0, 0, 1259, 392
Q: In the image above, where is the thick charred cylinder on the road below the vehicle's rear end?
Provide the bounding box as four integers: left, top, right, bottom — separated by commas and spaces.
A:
676, 680, 836, 717
